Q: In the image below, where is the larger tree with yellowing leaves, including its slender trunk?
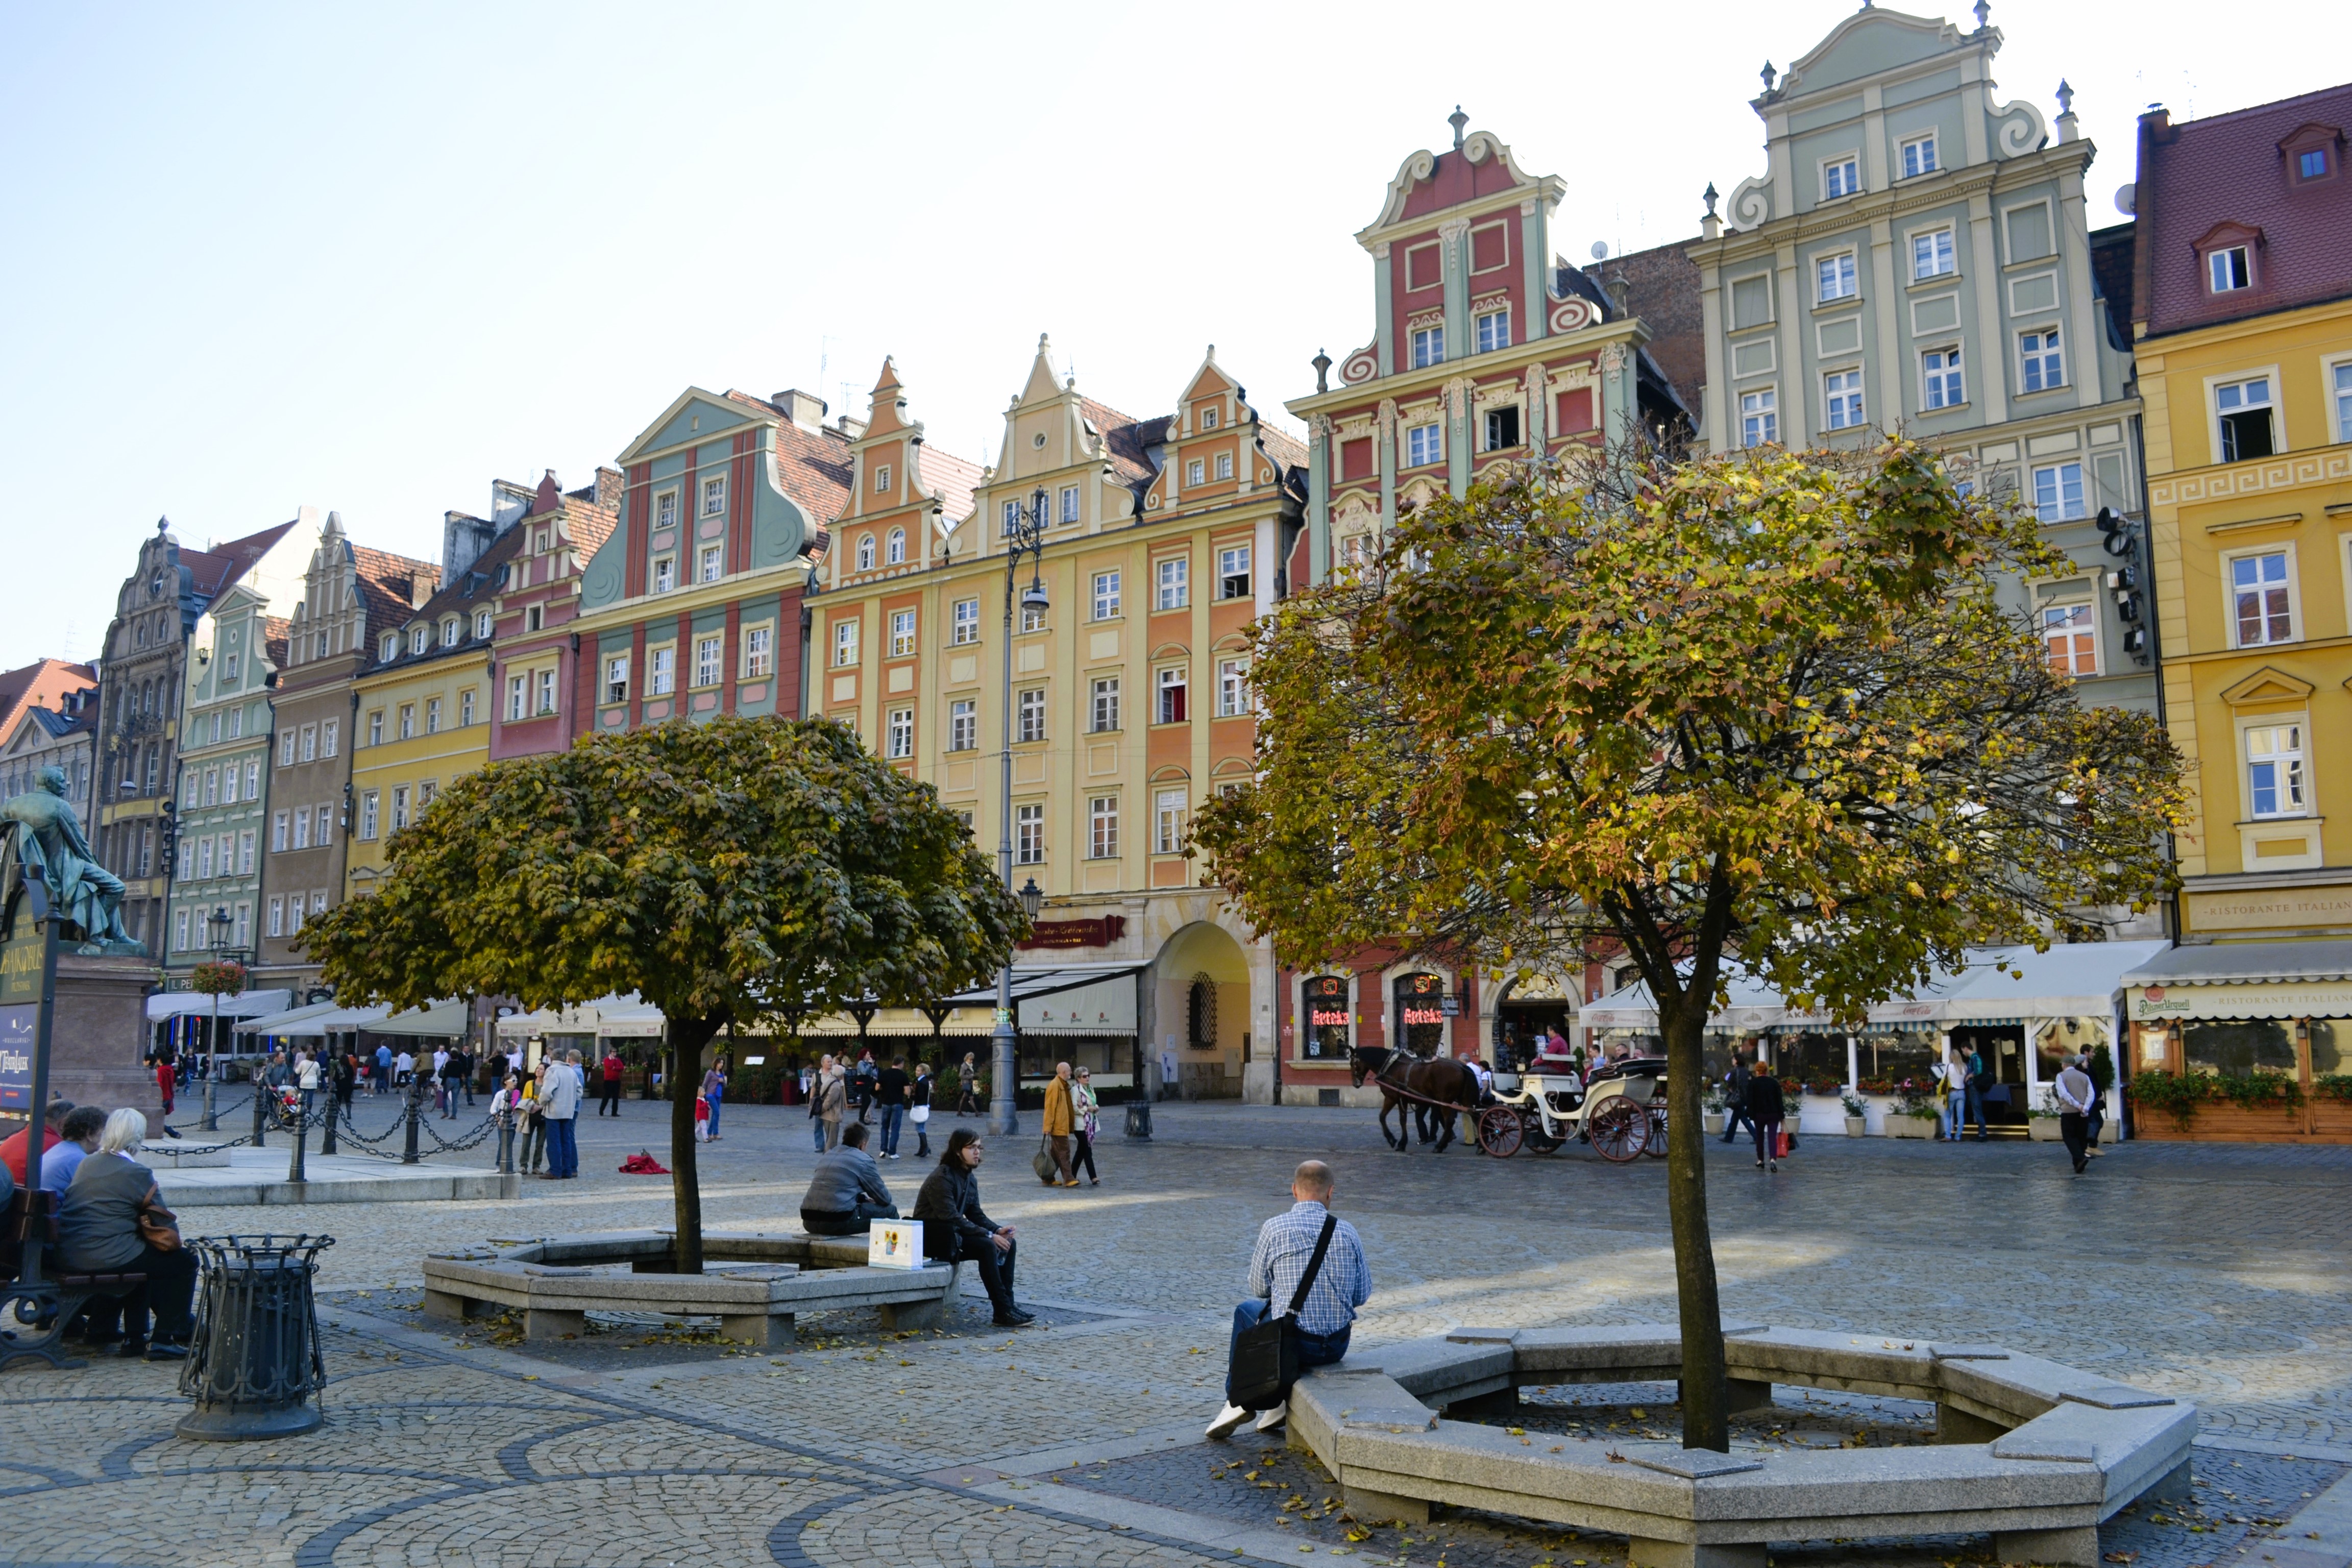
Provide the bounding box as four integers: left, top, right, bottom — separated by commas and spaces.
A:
1195, 439, 2183, 1448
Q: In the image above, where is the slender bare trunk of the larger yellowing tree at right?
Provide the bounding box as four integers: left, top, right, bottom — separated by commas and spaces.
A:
1658, 1001, 1731, 1453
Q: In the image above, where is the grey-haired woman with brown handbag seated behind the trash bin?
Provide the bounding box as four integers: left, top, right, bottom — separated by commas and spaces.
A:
57, 1107, 195, 1361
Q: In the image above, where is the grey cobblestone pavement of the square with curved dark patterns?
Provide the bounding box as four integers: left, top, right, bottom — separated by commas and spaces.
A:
0, 1102, 2352, 1568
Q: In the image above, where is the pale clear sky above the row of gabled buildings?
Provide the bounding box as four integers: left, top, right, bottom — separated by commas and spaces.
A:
0, 0, 2345, 668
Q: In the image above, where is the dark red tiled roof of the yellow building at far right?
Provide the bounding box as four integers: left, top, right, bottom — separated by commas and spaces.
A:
2131, 85, 2352, 336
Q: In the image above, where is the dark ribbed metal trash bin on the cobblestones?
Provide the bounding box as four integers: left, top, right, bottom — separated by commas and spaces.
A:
174, 1234, 334, 1443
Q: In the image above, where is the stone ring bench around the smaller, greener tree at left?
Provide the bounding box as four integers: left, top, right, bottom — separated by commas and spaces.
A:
426, 1230, 957, 1347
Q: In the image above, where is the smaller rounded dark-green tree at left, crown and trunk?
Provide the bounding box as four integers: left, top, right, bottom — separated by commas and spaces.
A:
303, 717, 1025, 1274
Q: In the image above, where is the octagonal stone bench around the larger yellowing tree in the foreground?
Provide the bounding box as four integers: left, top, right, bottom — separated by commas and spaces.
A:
1289, 1324, 2197, 1568
